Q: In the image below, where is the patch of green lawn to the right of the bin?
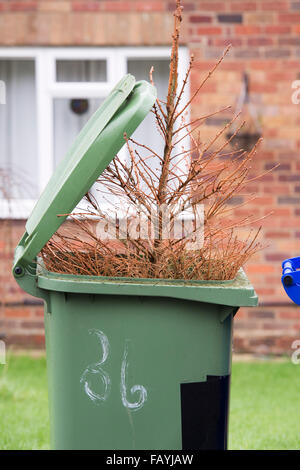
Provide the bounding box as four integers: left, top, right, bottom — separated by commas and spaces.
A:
229, 361, 300, 450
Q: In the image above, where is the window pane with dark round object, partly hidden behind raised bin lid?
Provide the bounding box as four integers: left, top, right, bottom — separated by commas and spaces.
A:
54, 98, 103, 166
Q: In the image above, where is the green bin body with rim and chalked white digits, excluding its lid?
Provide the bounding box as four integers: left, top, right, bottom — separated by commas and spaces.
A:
39, 266, 256, 450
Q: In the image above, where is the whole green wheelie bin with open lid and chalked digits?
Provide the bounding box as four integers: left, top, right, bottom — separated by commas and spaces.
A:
13, 75, 257, 450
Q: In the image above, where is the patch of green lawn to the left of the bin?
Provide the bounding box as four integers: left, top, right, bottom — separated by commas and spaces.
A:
0, 355, 49, 450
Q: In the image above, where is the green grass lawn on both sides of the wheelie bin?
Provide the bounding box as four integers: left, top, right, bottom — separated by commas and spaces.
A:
0, 355, 300, 449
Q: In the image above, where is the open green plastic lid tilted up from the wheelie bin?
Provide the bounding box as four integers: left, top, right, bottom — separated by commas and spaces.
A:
13, 74, 156, 276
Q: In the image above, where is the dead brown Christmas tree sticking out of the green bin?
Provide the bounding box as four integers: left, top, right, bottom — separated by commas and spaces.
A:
42, 0, 271, 280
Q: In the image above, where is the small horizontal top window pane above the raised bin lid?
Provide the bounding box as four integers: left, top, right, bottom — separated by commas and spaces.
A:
56, 60, 107, 82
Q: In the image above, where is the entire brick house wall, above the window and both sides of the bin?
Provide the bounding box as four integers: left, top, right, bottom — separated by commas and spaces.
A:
0, 0, 300, 354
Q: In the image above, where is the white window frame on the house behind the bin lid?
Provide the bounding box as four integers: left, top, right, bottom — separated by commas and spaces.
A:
0, 47, 189, 219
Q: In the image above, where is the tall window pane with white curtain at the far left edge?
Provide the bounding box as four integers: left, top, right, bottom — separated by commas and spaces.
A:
0, 60, 38, 199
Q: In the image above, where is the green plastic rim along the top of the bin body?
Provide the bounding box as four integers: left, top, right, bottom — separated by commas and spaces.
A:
37, 262, 258, 307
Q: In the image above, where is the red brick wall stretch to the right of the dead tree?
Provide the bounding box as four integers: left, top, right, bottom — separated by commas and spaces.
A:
187, 0, 300, 354
